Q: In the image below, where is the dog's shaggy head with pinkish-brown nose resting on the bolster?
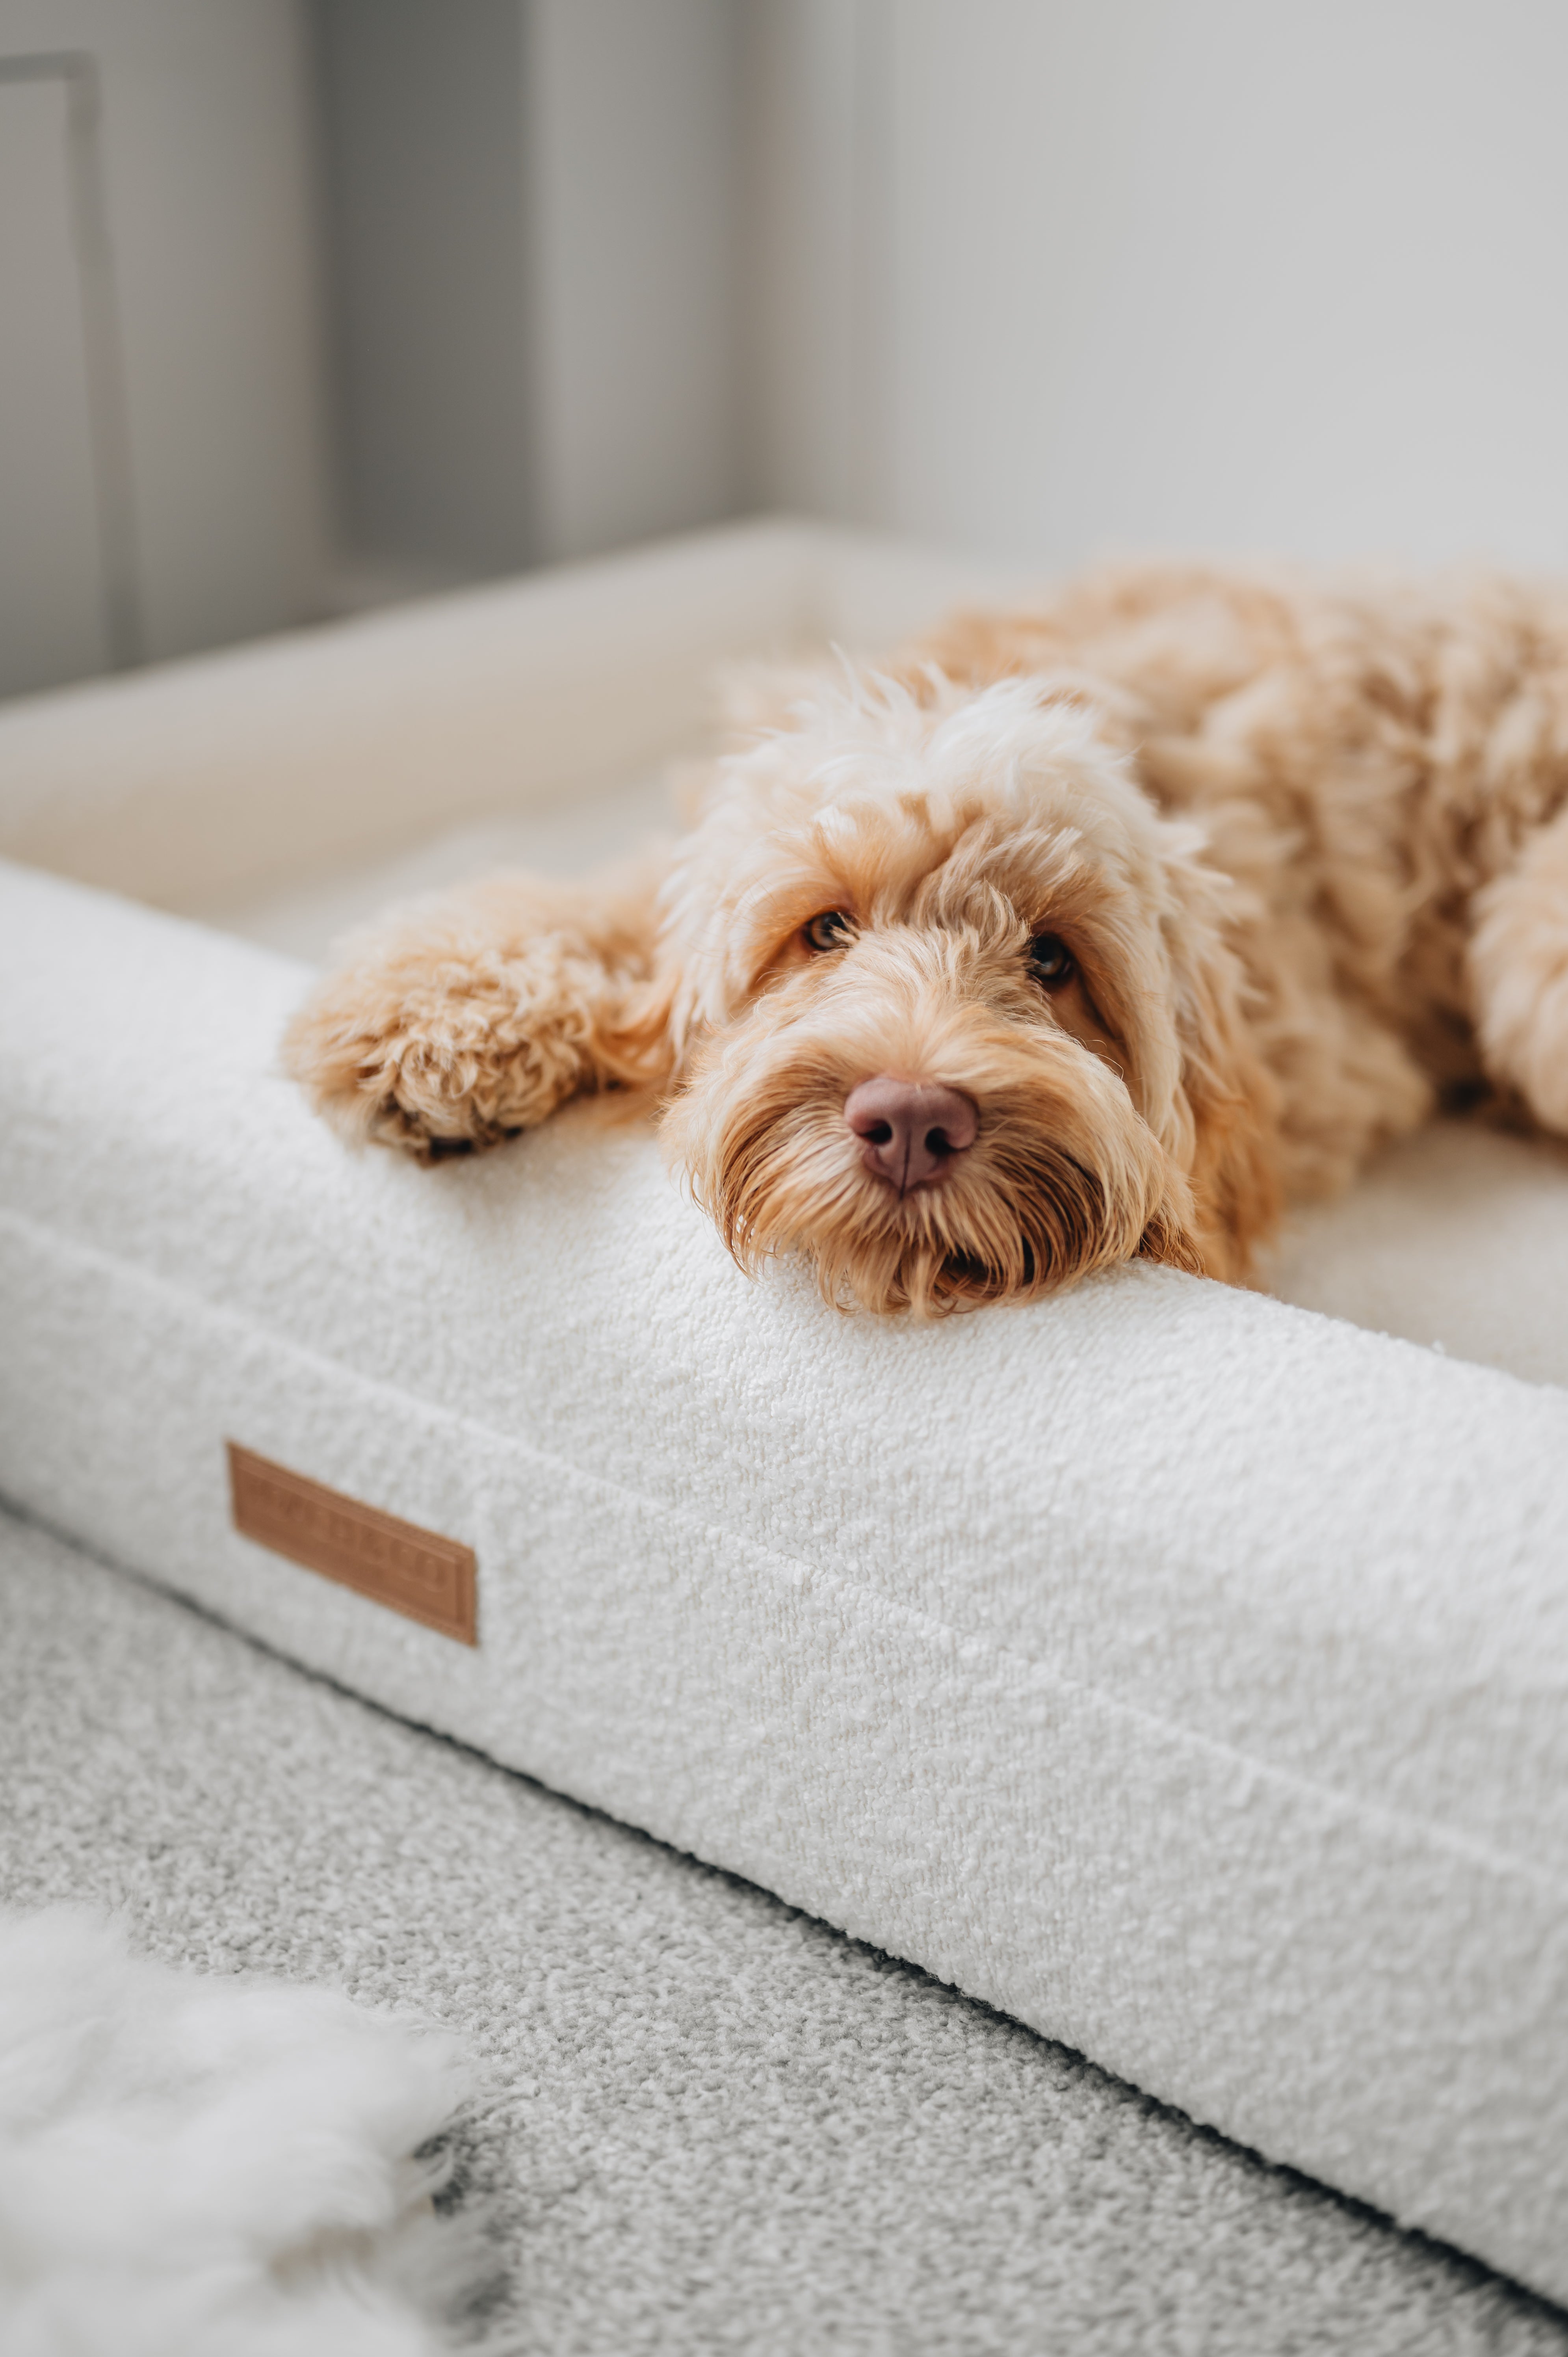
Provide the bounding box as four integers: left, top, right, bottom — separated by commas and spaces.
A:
665, 677, 1273, 1313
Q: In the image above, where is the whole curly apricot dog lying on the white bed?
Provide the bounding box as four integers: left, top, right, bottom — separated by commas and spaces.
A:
288, 568, 1568, 1308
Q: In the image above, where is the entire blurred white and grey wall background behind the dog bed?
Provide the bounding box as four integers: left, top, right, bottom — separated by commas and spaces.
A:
0, 0, 1568, 691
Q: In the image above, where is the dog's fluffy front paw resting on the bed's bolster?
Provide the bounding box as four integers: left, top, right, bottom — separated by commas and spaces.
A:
283, 924, 606, 1162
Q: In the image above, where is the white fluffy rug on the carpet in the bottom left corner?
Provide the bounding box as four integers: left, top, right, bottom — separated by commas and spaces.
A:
0, 1907, 462, 2357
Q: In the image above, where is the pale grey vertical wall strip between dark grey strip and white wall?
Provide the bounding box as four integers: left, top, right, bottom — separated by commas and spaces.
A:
524, 0, 750, 556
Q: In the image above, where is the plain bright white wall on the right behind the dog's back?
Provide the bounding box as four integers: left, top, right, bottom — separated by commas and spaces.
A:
747, 0, 1568, 568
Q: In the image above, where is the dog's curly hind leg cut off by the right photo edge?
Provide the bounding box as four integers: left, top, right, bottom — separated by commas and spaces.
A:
1469, 809, 1568, 1136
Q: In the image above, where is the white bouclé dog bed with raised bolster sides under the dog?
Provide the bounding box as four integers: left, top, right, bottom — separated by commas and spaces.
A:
0, 528, 1568, 2298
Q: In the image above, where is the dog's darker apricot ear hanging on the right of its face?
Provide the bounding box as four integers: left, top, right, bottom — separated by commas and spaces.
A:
1144, 849, 1283, 1284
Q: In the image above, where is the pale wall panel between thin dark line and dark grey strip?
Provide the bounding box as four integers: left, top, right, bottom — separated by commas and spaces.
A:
0, 0, 328, 688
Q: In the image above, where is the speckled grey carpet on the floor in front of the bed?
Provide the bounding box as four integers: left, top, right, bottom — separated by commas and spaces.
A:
0, 1522, 1568, 2357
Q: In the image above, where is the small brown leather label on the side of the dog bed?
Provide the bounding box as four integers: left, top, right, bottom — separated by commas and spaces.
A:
227, 1440, 479, 1645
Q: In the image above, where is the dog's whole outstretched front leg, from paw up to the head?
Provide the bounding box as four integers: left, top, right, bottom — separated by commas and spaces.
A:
283, 867, 663, 1160
